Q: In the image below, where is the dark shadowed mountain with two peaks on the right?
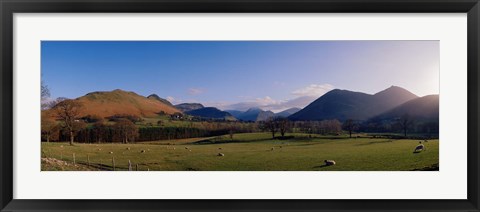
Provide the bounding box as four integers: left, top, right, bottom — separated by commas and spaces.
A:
289, 86, 418, 121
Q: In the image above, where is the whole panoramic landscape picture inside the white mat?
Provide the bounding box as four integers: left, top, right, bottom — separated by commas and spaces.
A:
40, 41, 440, 171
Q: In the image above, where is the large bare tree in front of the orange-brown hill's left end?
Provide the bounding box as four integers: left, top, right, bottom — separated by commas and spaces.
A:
55, 99, 82, 145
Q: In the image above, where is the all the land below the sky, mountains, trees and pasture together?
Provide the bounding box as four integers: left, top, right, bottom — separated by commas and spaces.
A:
42, 86, 439, 171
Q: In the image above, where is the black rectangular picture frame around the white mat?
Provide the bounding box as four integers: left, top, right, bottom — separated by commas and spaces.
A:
0, 0, 480, 211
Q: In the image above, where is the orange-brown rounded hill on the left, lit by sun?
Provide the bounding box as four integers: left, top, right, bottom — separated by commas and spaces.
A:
52, 89, 180, 117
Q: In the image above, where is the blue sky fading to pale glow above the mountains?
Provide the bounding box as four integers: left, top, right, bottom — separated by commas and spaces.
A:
41, 41, 439, 112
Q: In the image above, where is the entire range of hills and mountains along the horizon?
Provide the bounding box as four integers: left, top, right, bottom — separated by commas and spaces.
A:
45, 86, 439, 121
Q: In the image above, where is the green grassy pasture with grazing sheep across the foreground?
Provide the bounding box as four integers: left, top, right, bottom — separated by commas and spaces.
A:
42, 133, 439, 171
